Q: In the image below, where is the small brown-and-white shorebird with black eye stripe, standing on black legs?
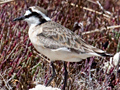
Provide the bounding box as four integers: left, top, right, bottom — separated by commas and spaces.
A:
13, 6, 113, 90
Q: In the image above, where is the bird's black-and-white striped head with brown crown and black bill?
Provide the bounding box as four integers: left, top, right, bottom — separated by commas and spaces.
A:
14, 6, 51, 25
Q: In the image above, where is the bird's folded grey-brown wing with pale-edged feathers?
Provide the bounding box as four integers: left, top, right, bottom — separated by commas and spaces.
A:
37, 22, 104, 53
